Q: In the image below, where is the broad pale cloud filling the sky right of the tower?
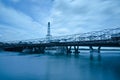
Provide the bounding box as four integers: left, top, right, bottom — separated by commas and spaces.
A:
48, 0, 120, 35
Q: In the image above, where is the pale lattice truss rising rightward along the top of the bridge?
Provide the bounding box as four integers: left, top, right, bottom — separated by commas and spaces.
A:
2, 28, 120, 44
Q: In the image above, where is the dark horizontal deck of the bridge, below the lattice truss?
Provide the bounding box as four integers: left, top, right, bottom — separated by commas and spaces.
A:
4, 40, 120, 48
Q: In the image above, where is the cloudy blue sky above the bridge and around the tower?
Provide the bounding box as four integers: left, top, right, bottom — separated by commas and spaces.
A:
0, 0, 120, 41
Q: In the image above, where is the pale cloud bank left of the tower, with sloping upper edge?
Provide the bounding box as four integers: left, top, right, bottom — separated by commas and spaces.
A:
0, 1, 45, 40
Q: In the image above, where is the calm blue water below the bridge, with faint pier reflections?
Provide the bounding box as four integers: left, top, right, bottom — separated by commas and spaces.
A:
0, 52, 120, 80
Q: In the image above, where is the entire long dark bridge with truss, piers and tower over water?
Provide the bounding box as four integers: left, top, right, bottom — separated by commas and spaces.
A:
0, 22, 120, 54
